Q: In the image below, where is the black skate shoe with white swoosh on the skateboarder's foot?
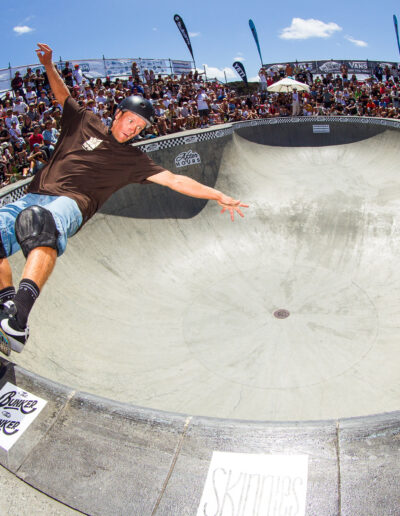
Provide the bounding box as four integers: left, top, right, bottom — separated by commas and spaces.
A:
0, 301, 29, 356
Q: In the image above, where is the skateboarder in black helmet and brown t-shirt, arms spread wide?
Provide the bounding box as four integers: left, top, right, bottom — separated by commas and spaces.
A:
0, 43, 248, 355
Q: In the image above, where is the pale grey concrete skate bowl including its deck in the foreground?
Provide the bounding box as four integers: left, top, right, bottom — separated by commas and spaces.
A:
0, 119, 400, 515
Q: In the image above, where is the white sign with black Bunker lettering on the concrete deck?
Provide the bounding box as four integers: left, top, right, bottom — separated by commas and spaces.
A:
0, 382, 47, 451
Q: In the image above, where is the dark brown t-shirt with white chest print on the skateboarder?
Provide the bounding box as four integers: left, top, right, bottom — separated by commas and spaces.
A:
28, 97, 165, 223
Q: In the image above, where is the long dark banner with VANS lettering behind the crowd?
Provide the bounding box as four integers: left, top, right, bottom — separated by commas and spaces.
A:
264, 59, 398, 76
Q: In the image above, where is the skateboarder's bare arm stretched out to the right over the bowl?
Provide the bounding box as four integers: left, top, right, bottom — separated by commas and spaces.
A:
147, 170, 249, 220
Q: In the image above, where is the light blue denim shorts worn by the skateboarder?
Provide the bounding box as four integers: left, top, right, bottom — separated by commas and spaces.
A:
0, 194, 82, 256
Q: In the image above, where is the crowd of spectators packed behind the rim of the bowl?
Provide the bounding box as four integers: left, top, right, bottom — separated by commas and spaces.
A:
0, 62, 400, 186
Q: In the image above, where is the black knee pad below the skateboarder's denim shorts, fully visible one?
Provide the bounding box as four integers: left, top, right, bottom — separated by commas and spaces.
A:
15, 206, 59, 258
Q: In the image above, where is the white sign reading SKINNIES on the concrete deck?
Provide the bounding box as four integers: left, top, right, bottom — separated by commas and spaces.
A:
197, 452, 308, 516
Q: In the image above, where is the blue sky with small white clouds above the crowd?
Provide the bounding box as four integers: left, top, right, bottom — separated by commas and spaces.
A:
0, 0, 400, 80
